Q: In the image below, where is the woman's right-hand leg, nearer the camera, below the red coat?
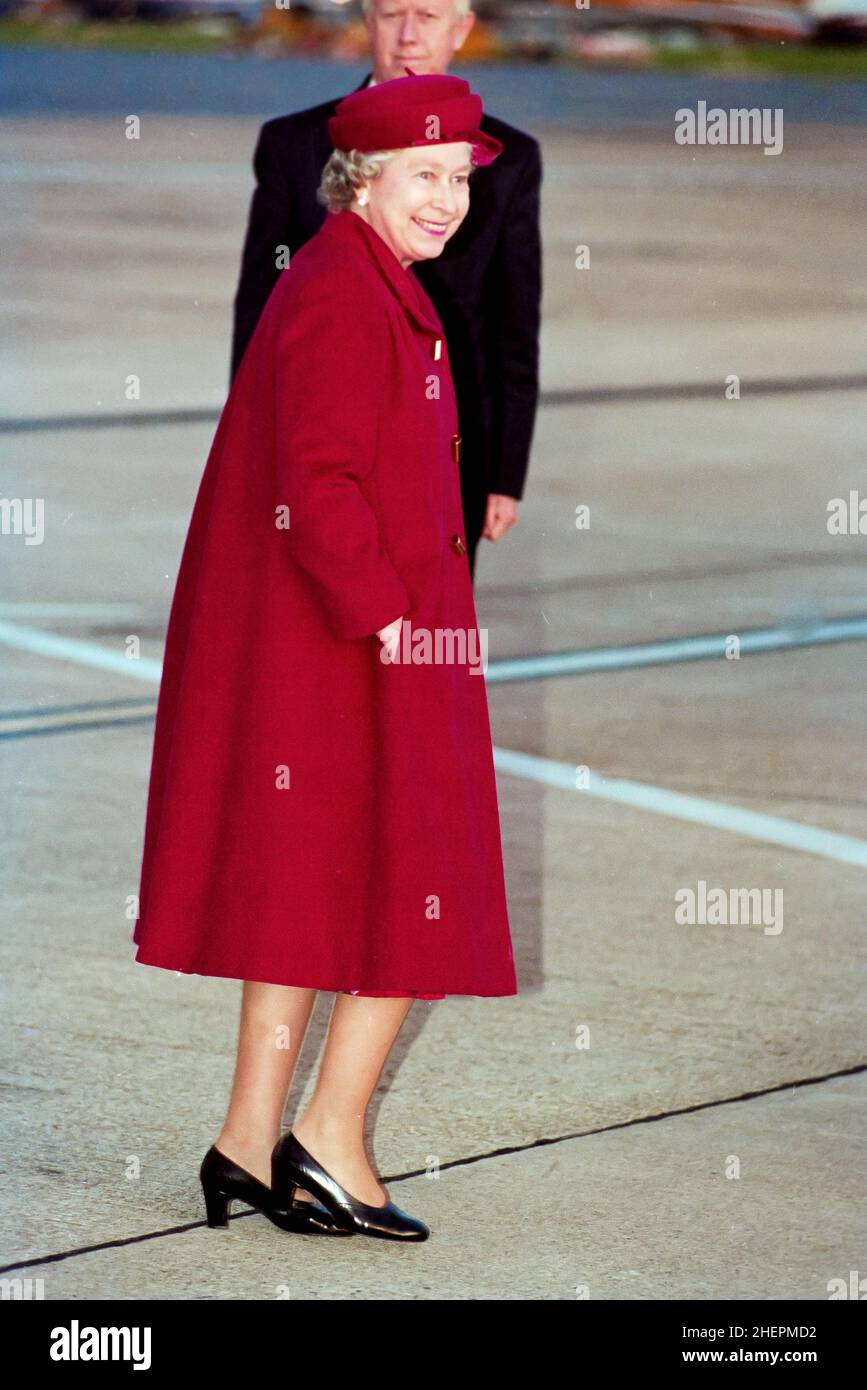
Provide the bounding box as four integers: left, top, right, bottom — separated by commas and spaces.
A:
292, 994, 413, 1207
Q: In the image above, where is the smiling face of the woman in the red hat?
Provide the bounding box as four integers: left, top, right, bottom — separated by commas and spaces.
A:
352, 140, 472, 267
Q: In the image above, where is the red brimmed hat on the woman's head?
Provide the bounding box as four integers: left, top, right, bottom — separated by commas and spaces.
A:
328, 68, 503, 164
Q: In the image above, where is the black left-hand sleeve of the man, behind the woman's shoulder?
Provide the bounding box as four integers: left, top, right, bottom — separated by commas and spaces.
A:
229, 124, 292, 379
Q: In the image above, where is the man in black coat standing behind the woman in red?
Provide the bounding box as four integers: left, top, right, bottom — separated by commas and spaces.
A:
232, 0, 542, 574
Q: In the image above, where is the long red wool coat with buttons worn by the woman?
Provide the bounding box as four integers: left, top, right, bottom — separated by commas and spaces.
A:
133, 202, 517, 998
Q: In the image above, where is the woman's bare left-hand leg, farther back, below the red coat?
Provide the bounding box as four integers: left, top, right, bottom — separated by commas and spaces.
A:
215, 980, 317, 1198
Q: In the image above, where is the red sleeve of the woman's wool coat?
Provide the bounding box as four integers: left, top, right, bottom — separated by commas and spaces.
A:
275, 271, 411, 639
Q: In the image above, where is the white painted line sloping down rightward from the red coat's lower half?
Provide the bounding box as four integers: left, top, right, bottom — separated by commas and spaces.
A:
493, 748, 867, 869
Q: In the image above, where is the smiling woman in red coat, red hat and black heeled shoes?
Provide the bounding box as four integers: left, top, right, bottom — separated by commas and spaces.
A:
133, 75, 517, 1240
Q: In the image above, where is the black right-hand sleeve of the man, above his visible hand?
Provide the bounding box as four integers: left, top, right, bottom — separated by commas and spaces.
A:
488, 140, 542, 498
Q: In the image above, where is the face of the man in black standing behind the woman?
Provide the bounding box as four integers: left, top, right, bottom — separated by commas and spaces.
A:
364, 0, 475, 82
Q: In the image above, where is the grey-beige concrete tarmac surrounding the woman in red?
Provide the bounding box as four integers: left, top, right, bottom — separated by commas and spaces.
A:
0, 113, 867, 1301
